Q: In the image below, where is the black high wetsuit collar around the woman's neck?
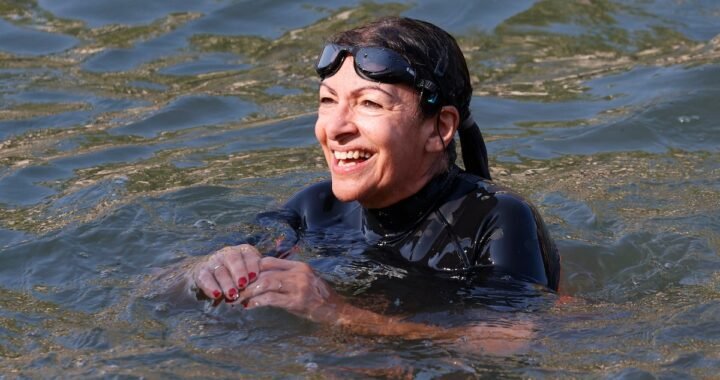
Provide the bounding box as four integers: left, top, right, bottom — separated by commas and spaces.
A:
363, 165, 460, 242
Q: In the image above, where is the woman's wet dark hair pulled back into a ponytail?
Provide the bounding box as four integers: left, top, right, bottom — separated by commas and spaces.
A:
328, 17, 490, 179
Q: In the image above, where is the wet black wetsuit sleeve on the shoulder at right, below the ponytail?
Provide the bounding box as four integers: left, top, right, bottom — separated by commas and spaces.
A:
477, 194, 559, 289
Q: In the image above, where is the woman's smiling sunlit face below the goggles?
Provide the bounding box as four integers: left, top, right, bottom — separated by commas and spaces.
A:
315, 56, 438, 208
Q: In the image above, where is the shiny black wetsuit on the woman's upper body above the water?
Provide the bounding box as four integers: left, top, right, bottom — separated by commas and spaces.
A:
276, 165, 560, 290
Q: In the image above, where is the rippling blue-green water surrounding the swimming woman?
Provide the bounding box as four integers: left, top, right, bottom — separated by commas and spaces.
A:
0, 0, 720, 379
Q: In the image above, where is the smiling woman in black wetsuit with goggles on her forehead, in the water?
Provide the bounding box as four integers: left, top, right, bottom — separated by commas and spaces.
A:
180, 18, 560, 351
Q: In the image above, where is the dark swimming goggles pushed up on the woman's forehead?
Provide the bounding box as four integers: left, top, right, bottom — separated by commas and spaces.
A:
315, 44, 438, 92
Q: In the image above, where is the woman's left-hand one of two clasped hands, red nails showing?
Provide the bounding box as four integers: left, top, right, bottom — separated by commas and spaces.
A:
192, 244, 262, 302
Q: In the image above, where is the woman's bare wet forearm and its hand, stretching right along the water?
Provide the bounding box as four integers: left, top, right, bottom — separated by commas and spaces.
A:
238, 257, 533, 354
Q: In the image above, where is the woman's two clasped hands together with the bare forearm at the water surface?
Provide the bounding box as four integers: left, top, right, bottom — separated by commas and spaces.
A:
188, 244, 534, 355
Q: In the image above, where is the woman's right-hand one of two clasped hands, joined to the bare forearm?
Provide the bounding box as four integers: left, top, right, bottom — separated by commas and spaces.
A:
240, 257, 344, 323
